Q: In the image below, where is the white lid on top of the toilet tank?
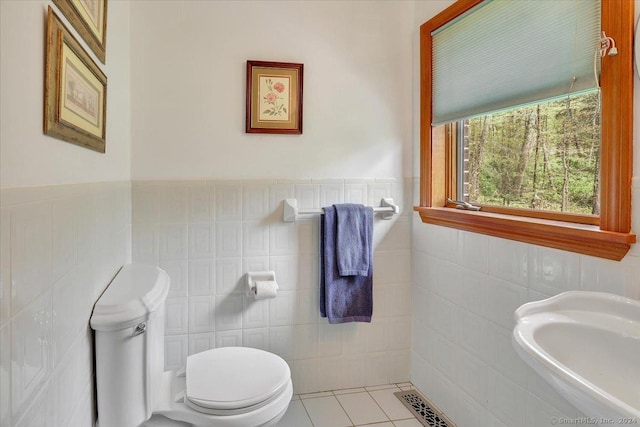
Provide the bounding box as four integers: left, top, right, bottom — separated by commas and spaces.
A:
91, 264, 169, 331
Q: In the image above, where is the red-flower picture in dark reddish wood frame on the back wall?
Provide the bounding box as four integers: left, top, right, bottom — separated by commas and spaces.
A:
246, 61, 304, 134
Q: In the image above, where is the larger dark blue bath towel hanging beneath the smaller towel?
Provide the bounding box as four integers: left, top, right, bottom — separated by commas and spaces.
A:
320, 205, 373, 323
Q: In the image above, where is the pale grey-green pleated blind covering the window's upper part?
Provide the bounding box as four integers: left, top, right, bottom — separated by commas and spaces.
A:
432, 0, 600, 125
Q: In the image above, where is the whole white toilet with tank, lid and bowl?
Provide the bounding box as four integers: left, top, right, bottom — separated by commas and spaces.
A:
91, 264, 293, 427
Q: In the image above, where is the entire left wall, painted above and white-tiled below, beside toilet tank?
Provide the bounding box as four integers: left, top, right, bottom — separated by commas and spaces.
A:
0, 0, 131, 427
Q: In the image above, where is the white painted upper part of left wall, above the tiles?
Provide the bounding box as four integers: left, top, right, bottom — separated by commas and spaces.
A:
0, 0, 131, 188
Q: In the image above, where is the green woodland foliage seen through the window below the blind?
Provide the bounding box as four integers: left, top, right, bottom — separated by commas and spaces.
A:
465, 92, 600, 214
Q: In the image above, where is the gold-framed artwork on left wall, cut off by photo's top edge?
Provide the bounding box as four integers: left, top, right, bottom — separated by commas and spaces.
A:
53, 0, 107, 64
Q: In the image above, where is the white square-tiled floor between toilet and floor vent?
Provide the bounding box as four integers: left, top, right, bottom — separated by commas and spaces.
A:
278, 383, 422, 427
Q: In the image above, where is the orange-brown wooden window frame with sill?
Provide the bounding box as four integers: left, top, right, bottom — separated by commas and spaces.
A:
414, 0, 636, 260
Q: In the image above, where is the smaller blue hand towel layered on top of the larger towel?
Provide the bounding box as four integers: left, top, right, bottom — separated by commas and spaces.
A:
333, 203, 373, 276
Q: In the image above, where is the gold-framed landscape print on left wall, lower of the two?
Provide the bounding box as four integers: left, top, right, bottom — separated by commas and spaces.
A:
44, 7, 107, 153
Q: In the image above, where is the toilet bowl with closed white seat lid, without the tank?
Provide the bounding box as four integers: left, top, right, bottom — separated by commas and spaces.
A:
153, 347, 293, 427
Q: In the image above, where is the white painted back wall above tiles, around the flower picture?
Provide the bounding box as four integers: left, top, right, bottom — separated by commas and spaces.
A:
131, 1, 413, 180
